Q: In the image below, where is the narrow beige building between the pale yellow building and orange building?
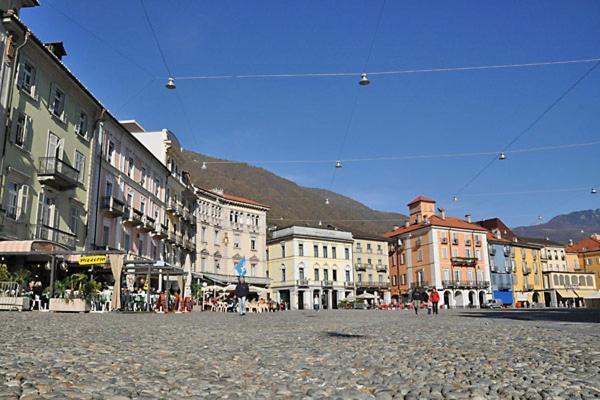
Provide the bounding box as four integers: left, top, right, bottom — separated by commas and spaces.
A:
352, 234, 391, 303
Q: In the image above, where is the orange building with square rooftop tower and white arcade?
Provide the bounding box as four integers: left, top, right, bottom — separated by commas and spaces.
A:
385, 196, 491, 307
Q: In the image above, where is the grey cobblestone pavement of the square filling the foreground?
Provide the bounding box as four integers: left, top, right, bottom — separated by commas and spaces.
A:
0, 311, 600, 399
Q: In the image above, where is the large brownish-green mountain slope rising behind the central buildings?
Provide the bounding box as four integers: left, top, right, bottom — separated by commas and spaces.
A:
183, 150, 407, 235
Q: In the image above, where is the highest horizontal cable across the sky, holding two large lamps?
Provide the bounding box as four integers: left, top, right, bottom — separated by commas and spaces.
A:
174, 57, 600, 80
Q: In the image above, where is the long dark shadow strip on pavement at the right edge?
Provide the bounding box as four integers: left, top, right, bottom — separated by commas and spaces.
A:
458, 309, 600, 323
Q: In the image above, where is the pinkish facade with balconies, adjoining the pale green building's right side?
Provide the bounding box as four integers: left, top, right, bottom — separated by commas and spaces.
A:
90, 114, 169, 261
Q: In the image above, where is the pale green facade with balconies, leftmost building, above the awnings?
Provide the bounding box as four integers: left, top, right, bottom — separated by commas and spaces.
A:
0, 15, 103, 250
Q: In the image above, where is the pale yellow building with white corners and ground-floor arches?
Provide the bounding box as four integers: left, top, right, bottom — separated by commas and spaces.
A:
267, 226, 354, 310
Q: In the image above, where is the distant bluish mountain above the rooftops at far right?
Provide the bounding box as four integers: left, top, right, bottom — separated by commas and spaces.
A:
513, 208, 600, 243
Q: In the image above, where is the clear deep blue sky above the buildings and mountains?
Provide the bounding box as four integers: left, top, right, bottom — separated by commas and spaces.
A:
21, 0, 600, 225
